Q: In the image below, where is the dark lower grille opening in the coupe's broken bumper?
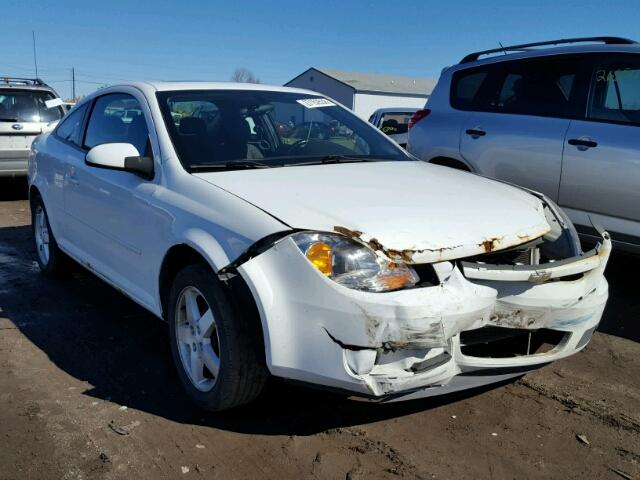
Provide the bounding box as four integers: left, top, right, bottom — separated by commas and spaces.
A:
460, 326, 570, 358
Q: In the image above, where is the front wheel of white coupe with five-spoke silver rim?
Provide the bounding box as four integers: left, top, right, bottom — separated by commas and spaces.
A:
167, 264, 268, 411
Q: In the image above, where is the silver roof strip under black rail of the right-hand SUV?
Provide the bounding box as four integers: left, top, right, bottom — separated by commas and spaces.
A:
451, 43, 640, 70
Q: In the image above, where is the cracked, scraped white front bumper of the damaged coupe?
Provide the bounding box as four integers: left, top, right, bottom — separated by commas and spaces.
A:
238, 233, 611, 400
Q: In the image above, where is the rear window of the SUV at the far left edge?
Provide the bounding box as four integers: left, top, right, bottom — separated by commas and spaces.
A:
0, 88, 64, 123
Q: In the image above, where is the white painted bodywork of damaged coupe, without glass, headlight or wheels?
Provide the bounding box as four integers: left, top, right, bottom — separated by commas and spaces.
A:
30, 83, 610, 404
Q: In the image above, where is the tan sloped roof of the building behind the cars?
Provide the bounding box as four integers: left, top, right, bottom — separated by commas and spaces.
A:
296, 67, 436, 96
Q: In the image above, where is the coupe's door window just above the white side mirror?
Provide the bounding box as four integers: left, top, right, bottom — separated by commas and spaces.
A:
84, 93, 151, 156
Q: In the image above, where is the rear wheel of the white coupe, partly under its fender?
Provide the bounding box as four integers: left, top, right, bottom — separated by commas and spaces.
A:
31, 195, 68, 276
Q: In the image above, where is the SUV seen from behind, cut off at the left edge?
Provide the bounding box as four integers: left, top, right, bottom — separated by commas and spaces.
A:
0, 77, 65, 177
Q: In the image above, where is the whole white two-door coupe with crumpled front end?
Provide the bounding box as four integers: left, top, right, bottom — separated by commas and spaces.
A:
29, 82, 611, 410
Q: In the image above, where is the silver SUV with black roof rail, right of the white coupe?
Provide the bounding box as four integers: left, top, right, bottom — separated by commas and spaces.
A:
407, 37, 640, 253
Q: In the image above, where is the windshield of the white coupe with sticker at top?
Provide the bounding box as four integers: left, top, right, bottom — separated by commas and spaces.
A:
158, 90, 410, 170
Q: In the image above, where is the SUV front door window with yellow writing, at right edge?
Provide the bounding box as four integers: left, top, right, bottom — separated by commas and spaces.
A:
587, 58, 640, 125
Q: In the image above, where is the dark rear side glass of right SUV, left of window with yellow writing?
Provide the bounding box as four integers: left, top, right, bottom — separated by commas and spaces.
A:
451, 57, 579, 117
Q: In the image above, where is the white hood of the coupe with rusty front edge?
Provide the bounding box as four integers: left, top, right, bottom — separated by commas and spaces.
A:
195, 161, 550, 263
